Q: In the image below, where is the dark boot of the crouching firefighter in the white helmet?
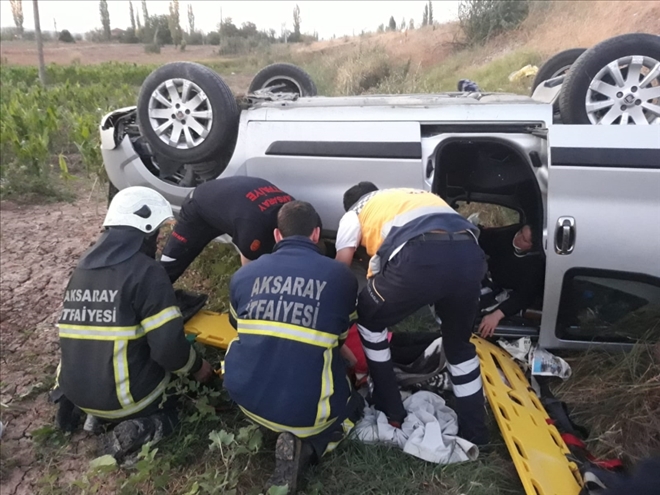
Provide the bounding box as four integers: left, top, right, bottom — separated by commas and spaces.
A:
99, 416, 163, 463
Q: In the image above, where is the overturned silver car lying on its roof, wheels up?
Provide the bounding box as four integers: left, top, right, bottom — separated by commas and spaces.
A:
100, 34, 660, 348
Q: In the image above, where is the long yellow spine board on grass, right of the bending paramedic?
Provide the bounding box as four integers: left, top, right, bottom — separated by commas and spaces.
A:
472, 336, 582, 495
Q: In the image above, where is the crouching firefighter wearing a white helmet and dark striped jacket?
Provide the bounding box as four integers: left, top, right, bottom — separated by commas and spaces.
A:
53, 187, 212, 460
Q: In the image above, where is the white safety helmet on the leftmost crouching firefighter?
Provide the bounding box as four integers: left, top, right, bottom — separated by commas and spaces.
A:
103, 186, 174, 234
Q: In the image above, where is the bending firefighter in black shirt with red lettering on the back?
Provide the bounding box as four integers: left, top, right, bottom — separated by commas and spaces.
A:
160, 176, 293, 283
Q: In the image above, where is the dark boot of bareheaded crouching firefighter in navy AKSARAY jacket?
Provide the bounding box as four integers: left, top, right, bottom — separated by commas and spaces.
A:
266, 432, 313, 495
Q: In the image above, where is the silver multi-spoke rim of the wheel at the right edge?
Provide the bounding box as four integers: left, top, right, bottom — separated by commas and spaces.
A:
585, 55, 660, 125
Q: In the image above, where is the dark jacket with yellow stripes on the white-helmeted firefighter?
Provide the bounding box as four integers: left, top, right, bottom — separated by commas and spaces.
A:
58, 252, 201, 419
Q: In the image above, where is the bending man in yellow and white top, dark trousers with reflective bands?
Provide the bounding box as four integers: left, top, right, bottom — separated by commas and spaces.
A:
336, 182, 488, 445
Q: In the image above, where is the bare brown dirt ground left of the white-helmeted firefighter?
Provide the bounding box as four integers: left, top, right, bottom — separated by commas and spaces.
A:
0, 185, 105, 495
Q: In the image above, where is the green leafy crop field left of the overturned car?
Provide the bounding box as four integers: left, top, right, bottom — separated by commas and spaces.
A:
0, 63, 141, 199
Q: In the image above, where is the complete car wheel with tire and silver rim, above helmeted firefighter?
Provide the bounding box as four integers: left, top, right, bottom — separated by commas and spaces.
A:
138, 62, 239, 164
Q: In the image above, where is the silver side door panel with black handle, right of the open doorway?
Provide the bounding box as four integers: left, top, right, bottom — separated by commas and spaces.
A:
540, 126, 660, 348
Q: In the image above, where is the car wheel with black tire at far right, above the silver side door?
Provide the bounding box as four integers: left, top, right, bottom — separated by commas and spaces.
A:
559, 33, 660, 125
